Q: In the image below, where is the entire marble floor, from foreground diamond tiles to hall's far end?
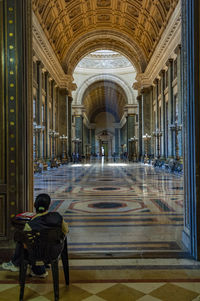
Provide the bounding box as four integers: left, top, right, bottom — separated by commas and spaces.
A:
0, 162, 200, 301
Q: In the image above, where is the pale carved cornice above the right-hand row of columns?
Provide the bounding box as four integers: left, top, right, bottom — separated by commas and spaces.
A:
134, 1, 181, 90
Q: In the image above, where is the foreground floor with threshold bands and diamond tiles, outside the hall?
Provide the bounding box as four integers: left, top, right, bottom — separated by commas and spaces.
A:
0, 259, 200, 301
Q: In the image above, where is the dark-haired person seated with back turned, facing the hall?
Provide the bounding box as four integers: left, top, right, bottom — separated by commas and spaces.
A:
2, 193, 68, 278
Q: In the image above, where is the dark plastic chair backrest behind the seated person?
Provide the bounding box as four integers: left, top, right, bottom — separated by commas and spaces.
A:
15, 228, 64, 263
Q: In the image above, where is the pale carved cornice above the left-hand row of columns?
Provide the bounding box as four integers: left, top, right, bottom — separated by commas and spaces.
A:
32, 12, 76, 90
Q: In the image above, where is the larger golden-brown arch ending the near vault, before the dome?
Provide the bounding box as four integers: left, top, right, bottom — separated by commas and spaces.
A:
62, 30, 147, 75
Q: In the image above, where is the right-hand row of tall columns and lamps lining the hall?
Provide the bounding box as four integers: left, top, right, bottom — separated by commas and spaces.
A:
137, 45, 183, 160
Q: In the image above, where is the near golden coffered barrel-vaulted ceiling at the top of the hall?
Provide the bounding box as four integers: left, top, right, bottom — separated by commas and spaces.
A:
33, 0, 178, 74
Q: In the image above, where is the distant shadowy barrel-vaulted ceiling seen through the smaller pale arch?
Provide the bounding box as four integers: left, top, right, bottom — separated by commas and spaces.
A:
83, 81, 127, 122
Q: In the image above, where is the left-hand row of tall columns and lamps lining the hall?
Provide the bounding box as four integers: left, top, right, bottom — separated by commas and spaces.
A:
33, 54, 73, 162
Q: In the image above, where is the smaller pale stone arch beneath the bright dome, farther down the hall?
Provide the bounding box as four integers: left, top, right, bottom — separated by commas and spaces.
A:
74, 74, 135, 105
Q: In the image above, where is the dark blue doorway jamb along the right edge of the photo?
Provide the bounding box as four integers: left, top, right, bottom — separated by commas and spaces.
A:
181, 0, 200, 260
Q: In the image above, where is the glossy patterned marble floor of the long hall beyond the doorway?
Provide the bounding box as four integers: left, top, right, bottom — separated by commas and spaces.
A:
35, 162, 186, 258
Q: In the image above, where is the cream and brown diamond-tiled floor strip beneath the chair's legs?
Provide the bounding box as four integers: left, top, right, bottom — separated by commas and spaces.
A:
0, 283, 200, 301
